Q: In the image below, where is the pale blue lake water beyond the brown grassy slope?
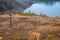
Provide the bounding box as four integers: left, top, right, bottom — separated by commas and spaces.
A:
24, 1, 60, 16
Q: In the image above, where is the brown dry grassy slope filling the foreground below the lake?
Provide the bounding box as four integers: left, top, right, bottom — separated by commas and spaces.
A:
0, 12, 60, 40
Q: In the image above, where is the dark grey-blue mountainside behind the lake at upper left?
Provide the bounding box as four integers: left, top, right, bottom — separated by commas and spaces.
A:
0, 0, 33, 12
